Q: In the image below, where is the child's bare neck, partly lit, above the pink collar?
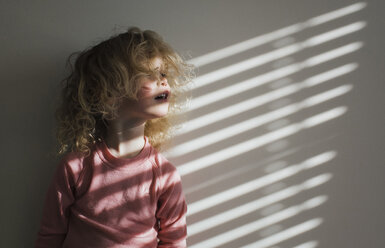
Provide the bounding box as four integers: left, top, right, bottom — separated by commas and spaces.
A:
105, 120, 145, 158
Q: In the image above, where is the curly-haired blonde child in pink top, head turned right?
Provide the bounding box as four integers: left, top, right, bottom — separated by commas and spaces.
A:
36, 28, 192, 248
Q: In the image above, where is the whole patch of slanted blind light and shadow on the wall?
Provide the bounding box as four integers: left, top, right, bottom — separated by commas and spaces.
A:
165, 2, 366, 248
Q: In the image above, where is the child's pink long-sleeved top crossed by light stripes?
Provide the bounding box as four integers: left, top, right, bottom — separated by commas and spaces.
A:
35, 137, 187, 248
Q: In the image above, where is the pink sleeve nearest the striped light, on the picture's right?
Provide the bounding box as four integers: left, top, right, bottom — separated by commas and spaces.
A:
156, 154, 187, 248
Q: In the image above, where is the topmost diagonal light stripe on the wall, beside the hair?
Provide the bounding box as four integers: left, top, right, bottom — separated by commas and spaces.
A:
188, 2, 366, 67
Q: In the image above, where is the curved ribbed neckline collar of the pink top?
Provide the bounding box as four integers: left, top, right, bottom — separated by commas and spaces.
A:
97, 136, 152, 170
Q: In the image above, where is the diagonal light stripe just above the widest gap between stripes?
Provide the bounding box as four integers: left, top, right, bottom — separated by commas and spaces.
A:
177, 107, 347, 176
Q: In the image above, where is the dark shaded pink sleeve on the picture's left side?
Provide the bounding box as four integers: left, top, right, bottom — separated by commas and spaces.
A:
35, 158, 75, 248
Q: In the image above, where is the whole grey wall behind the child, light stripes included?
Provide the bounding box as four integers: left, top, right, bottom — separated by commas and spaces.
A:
0, 0, 385, 248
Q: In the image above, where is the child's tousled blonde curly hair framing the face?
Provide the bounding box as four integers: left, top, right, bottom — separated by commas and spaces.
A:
56, 27, 194, 154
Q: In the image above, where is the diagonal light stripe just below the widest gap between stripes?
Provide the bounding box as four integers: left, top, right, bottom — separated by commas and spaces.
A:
187, 151, 336, 216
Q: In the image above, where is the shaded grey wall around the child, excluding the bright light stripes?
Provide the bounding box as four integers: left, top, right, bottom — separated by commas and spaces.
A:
0, 0, 385, 248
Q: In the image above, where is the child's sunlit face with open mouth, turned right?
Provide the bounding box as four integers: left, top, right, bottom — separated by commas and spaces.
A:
118, 58, 171, 121
